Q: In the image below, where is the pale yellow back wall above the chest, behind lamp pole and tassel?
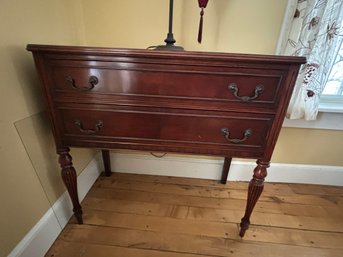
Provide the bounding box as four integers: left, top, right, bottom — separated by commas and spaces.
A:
83, 0, 287, 54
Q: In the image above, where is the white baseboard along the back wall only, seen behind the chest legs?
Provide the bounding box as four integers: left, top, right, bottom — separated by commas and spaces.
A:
111, 152, 343, 186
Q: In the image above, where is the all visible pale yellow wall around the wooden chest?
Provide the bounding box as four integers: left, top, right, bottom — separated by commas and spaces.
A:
0, 0, 343, 256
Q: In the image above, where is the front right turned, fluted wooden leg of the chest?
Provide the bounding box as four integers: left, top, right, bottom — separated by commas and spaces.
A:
239, 160, 269, 237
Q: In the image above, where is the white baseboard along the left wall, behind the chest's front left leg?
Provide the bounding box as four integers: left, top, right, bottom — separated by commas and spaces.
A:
8, 156, 101, 257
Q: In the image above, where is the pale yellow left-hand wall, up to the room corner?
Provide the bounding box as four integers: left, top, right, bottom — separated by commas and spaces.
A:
0, 0, 92, 256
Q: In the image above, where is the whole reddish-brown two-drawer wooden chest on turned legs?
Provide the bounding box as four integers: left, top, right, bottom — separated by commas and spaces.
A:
27, 45, 305, 236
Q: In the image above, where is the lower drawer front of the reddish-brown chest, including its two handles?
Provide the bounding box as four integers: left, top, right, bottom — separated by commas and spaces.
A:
59, 108, 272, 150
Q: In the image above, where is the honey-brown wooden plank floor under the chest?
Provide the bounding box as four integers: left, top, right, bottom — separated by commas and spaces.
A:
46, 173, 343, 257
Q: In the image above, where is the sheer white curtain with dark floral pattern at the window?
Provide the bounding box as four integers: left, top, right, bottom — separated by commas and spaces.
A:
281, 0, 343, 120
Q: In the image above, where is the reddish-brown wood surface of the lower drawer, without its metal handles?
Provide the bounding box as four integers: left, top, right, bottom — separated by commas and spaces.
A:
56, 106, 271, 157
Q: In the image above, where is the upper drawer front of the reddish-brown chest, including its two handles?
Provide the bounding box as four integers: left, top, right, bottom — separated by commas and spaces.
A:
51, 63, 284, 108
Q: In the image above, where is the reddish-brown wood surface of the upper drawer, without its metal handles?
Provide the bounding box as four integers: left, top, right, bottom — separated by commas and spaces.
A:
50, 61, 283, 105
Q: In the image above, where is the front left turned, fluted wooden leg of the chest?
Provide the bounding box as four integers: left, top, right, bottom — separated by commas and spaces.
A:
57, 148, 83, 224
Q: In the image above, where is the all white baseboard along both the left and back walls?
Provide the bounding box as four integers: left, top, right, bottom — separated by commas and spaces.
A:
8, 152, 343, 257
